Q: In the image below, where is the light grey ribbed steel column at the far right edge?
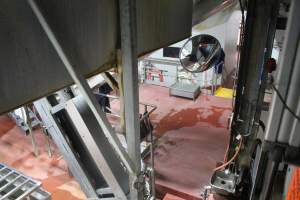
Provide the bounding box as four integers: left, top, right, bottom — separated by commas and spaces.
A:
253, 0, 300, 199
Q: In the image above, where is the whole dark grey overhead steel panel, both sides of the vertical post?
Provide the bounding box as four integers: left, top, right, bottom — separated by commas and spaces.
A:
0, 0, 192, 113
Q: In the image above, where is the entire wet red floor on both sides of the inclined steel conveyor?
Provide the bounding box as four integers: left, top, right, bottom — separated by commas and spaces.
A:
0, 85, 231, 200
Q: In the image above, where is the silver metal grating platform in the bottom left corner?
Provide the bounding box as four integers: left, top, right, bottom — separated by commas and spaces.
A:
0, 164, 51, 200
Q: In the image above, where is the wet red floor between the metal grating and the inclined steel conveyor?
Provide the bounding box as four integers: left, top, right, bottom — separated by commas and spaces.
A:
0, 115, 86, 200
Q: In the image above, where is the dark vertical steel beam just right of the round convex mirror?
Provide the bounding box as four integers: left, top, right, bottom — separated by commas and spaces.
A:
234, 0, 278, 136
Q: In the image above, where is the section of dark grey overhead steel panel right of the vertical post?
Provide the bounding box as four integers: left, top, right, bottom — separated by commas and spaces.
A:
137, 0, 193, 55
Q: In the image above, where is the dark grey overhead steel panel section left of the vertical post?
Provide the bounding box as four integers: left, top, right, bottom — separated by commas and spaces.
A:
0, 0, 117, 113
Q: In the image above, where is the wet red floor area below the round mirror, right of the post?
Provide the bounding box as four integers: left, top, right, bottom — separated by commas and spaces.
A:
140, 85, 231, 199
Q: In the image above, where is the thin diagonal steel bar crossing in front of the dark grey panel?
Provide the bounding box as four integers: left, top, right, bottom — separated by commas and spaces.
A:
28, 0, 135, 173
